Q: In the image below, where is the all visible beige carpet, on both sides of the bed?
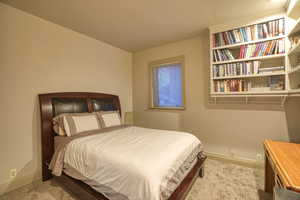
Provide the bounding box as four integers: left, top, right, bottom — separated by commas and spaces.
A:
0, 159, 272, 200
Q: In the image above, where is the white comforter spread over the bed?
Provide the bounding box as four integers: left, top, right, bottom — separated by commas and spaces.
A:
64, 127, 200, 200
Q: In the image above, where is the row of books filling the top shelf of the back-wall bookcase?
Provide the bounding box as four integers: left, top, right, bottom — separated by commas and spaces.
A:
213, 18, 284, 47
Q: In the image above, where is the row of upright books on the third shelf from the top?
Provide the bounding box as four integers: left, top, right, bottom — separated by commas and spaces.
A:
213, 61, 261, 77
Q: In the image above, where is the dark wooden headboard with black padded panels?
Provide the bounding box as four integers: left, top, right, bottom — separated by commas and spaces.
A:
39, 92, 121, 181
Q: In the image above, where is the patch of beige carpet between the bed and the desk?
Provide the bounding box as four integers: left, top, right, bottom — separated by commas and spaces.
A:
187, 160, 272, 200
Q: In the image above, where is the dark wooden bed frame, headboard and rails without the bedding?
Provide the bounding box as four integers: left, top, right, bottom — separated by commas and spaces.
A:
39, 92, 206, 200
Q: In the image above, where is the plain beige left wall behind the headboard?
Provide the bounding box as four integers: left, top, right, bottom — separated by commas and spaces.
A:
0, 3, 132, 193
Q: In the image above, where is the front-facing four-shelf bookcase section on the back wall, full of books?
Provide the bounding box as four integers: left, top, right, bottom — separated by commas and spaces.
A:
210, 15, 288, 96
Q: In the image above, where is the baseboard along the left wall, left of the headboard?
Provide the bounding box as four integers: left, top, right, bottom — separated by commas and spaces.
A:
0, 172, 42, 195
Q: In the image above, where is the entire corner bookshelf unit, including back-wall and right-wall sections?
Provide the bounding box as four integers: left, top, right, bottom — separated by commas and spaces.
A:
210, 0, 300, 102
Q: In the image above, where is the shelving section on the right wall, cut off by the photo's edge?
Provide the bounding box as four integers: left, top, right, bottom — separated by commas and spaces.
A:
286, 0, 300, 94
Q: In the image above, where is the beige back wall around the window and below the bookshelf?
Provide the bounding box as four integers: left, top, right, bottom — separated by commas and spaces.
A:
133, 32, 300, 162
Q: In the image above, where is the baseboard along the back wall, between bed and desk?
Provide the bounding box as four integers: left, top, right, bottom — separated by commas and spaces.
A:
205, 152, 264, 168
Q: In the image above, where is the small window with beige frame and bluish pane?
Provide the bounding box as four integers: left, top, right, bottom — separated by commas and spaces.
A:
150, 56, 184, 109
